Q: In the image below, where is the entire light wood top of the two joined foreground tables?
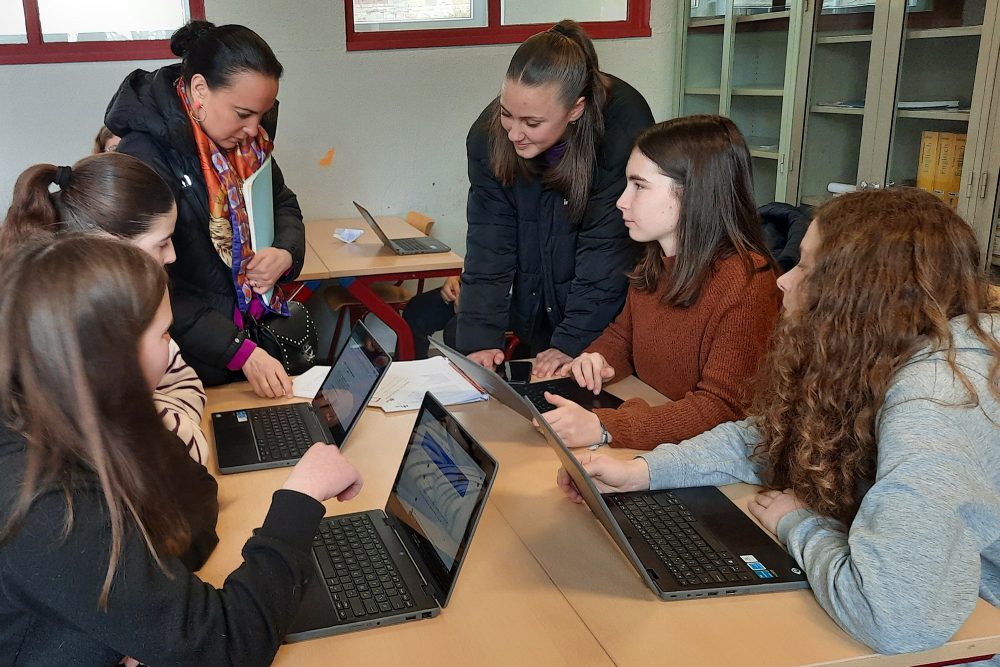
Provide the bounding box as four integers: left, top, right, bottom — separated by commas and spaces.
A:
201, 378, 1000, 667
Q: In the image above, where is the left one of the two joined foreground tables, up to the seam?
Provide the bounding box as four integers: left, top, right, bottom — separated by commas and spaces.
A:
199, 383, 612, 667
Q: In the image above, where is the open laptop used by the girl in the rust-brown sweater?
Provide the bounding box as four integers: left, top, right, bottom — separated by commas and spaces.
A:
430, 338, 623, 419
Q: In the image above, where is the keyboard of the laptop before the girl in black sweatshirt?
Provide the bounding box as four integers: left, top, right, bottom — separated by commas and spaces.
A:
313, 515, 413, 621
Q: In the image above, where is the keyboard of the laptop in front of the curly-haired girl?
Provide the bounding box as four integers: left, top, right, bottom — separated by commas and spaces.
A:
605, 492, 756, 586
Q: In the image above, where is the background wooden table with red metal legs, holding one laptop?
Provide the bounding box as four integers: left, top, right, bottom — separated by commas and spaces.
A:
300, 216, 463, 361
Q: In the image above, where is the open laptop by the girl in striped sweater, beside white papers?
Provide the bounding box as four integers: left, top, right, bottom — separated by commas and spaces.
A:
212, 322, 390, 473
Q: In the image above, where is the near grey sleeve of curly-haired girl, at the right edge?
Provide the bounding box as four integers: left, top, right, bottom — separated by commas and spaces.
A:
778, 399, 1000, 653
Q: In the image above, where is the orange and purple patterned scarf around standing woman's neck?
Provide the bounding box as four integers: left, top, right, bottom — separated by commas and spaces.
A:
177, 78, 288, 315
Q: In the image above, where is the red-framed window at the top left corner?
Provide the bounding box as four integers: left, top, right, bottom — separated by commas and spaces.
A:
0, 0, 205, 65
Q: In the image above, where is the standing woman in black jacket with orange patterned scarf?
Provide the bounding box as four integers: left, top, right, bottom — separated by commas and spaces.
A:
105, 21, 305, 398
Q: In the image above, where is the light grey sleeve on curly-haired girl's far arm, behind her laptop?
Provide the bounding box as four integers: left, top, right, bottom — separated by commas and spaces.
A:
639, 420, 761, 490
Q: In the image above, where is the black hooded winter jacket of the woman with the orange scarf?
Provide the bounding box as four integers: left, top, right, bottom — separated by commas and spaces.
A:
104, 65, 305, 385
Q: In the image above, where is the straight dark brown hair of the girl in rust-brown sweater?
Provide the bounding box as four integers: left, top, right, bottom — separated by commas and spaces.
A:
629, 116, 777, 307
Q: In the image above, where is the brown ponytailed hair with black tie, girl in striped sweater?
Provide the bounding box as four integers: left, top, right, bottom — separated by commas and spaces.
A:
0, 153, 174, 246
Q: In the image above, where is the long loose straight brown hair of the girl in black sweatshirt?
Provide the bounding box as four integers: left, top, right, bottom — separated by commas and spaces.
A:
0, 233, 191, 608
